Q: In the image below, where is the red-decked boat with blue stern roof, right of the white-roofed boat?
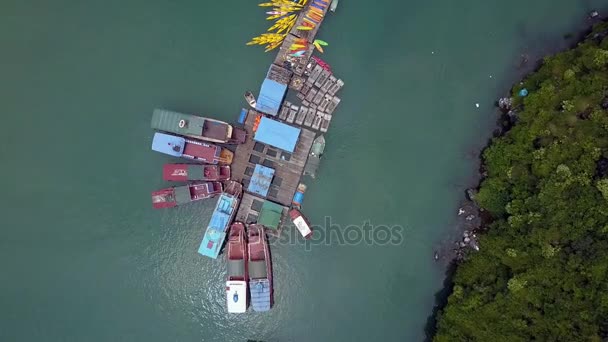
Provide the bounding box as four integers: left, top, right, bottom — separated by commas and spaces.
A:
247, 224, 273, 311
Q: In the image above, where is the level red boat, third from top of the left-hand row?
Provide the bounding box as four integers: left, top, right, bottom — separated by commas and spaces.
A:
163, 164, 230, 182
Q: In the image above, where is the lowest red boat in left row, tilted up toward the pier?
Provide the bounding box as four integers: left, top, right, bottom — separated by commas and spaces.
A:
152, 182, 222, 209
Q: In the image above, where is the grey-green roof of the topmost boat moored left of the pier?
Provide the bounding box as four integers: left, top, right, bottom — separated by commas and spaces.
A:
151, 109, 206, 136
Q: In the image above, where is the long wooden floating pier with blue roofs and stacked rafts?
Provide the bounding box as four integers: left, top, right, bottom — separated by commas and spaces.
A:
204, 0, 344, 239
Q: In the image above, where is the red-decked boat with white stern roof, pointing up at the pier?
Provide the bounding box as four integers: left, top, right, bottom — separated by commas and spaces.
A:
226, 222, 249, 313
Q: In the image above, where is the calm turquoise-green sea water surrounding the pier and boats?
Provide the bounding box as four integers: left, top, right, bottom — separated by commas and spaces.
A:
0, 0, 603, 342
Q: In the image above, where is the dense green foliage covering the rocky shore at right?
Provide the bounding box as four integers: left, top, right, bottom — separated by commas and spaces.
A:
435, 24, 608, 342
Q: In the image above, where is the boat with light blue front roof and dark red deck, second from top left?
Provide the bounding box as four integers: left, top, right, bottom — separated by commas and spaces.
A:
152, 132, 234, 165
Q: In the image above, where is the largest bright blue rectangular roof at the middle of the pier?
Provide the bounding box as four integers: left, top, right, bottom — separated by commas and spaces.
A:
253, 117, 301, 153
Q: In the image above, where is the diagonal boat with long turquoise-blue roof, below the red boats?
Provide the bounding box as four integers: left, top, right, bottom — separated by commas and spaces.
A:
198, 181, 243, 259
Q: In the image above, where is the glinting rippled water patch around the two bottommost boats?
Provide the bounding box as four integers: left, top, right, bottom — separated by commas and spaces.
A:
145, 201, 308, 341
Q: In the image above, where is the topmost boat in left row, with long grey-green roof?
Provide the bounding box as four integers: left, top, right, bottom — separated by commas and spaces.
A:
151, 109, 246, 144
